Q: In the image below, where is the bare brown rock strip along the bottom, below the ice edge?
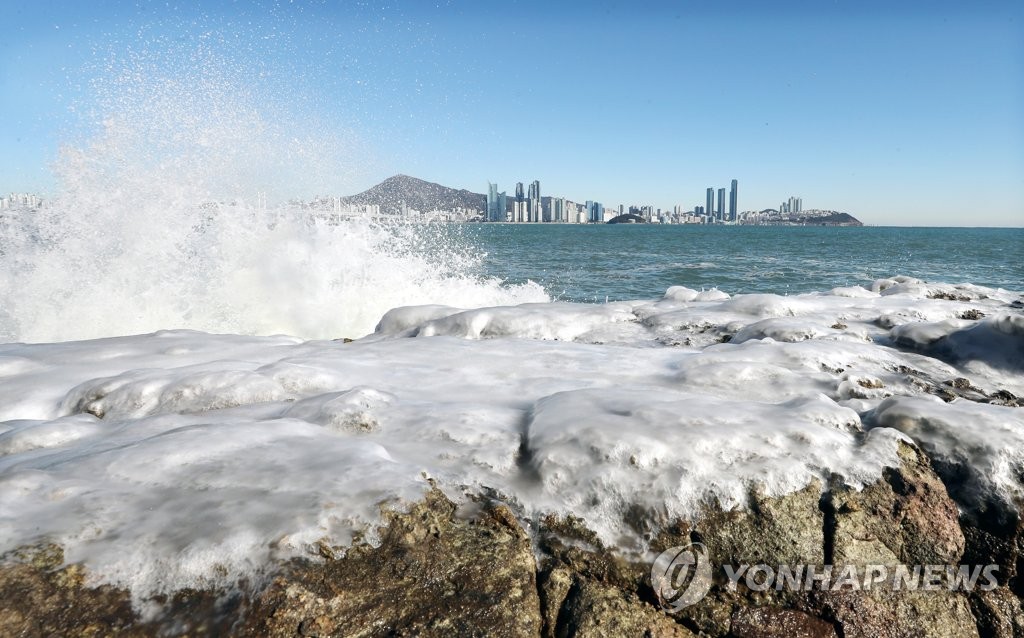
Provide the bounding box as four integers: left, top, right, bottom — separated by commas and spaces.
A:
0, 443, 1024, 638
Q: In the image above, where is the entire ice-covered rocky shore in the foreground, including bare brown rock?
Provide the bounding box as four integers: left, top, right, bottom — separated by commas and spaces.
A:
0, 278, 1024, 638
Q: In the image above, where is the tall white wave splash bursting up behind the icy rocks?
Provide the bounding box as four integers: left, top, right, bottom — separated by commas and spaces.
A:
0, 40, 547, 341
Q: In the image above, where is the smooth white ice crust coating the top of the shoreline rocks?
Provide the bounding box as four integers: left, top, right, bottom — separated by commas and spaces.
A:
0, 278, 1024, 597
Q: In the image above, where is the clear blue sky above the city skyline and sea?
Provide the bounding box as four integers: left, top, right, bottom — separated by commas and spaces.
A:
0, 0, 1024, 226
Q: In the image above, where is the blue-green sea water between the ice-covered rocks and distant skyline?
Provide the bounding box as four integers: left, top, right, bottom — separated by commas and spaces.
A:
466, 224, 1024, 302
